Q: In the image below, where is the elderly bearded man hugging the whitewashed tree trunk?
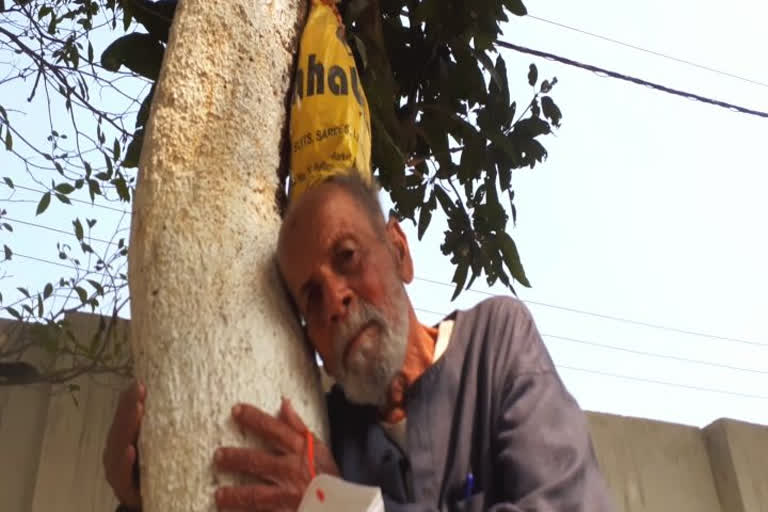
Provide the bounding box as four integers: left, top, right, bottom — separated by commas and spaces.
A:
104, 177, 612, 512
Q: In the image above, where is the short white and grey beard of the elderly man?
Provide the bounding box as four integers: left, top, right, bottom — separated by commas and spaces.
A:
333, 283, 409, 407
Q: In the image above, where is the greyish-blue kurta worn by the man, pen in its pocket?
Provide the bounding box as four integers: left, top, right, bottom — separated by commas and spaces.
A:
328, 297, 614, 512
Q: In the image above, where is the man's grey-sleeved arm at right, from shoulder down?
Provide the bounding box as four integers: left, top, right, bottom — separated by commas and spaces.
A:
491, 301, 613, 512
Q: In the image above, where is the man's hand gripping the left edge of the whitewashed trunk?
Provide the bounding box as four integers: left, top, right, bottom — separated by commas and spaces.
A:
102, 381, 147, 509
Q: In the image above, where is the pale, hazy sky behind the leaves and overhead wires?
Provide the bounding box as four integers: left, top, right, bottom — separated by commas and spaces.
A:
0, 0, 768, 426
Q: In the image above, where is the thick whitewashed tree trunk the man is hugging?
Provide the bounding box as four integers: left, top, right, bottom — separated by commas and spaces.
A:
129, 0, 327, 512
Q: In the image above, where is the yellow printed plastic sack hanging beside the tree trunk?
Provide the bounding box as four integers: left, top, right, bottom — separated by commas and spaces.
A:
290, 0, 371, 200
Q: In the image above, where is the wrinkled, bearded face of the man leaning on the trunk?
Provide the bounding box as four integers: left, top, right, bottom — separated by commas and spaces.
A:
278, 184, 413, 405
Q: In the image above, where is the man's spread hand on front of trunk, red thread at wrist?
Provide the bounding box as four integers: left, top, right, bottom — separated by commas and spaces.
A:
214, 399, 339, 511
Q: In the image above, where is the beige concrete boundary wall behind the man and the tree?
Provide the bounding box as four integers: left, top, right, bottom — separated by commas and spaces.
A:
0, 319, 768, 512
